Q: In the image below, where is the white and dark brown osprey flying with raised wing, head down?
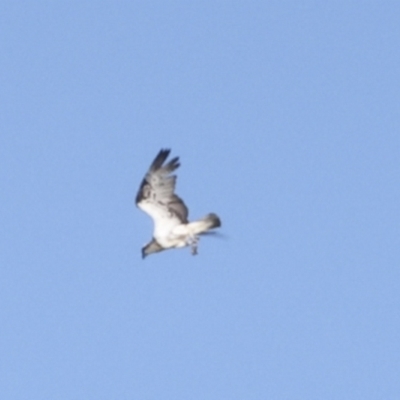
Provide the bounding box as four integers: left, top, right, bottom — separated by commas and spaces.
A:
136, 149, 221, 258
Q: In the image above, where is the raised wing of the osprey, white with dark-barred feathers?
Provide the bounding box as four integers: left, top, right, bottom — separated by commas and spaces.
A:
136, 149, 188, 237
